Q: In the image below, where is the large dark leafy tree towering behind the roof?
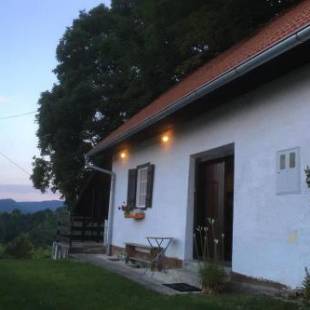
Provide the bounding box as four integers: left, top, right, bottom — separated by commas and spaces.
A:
32, 0, 298, 205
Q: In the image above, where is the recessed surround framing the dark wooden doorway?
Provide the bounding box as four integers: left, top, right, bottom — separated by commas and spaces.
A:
184, 143, 236, 261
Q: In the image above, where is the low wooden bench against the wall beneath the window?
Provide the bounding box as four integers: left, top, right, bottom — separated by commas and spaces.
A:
125, 243, 158, 265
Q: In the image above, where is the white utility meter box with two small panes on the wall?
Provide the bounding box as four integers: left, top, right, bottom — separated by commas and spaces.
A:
276, 148, 300, 194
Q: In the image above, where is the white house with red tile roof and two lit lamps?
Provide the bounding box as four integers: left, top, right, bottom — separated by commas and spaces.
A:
88, 0, 310, 287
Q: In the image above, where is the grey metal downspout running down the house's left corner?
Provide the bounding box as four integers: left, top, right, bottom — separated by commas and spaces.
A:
85, 155, 116, 255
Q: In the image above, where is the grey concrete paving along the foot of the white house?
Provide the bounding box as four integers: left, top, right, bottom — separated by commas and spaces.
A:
71, 253, 294, 297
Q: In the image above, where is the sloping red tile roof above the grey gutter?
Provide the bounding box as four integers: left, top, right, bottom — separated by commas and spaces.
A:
91, 0, 310, 153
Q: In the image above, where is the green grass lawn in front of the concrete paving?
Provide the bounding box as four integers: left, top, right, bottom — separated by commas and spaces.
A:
0, 259, 306, 310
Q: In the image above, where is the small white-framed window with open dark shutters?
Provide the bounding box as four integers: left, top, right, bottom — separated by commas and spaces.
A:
127, 164, 155, 209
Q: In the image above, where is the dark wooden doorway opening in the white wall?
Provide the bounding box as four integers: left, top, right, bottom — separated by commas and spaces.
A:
193, 155, 234, 264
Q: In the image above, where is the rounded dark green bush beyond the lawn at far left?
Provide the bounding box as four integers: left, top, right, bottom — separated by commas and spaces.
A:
4, 234, 33, 258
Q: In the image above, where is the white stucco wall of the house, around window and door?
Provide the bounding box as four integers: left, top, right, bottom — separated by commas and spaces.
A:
112, 63, 310, 287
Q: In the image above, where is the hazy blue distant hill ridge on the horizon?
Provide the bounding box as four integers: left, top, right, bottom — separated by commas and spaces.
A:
0, 199, 64, 213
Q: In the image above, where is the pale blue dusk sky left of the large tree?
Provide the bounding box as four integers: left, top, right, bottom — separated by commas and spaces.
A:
0, 0, 110, 201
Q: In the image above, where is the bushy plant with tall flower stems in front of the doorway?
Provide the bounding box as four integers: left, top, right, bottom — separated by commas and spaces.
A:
194, 218, 228, 294
